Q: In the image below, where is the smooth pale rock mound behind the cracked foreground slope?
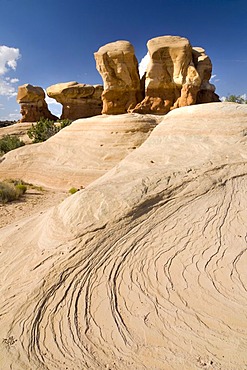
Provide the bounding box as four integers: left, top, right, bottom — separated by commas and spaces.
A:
0, 114, 161, 191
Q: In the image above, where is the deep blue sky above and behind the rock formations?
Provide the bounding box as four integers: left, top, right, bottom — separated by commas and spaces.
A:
0, 0, 247, 120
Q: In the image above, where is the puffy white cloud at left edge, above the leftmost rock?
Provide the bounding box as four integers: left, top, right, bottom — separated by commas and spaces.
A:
0, 45, 21, 97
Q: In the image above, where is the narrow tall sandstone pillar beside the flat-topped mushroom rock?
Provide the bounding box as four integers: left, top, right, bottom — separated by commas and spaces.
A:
94, 41, 142, 114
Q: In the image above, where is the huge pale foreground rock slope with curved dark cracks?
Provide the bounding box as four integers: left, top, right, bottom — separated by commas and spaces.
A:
0, 103, 247, 370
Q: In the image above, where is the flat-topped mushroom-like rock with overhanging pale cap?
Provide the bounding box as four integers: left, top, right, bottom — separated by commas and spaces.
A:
46, 81, 103, 120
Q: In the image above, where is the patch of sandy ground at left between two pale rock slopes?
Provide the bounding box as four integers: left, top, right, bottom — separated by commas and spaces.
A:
0, 189, 69, 228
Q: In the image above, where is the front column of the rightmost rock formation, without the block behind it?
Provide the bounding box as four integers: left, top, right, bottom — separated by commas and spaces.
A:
134, 36, 200, 114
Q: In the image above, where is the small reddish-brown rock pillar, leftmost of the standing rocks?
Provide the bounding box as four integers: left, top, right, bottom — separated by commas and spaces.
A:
17, 84, 58, 122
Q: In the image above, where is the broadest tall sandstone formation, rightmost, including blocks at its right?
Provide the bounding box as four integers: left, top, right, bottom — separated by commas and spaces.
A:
133, 36, 219, 114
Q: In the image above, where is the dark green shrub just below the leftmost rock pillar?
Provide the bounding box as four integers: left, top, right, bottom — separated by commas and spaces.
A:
27, 118, 60, 143
